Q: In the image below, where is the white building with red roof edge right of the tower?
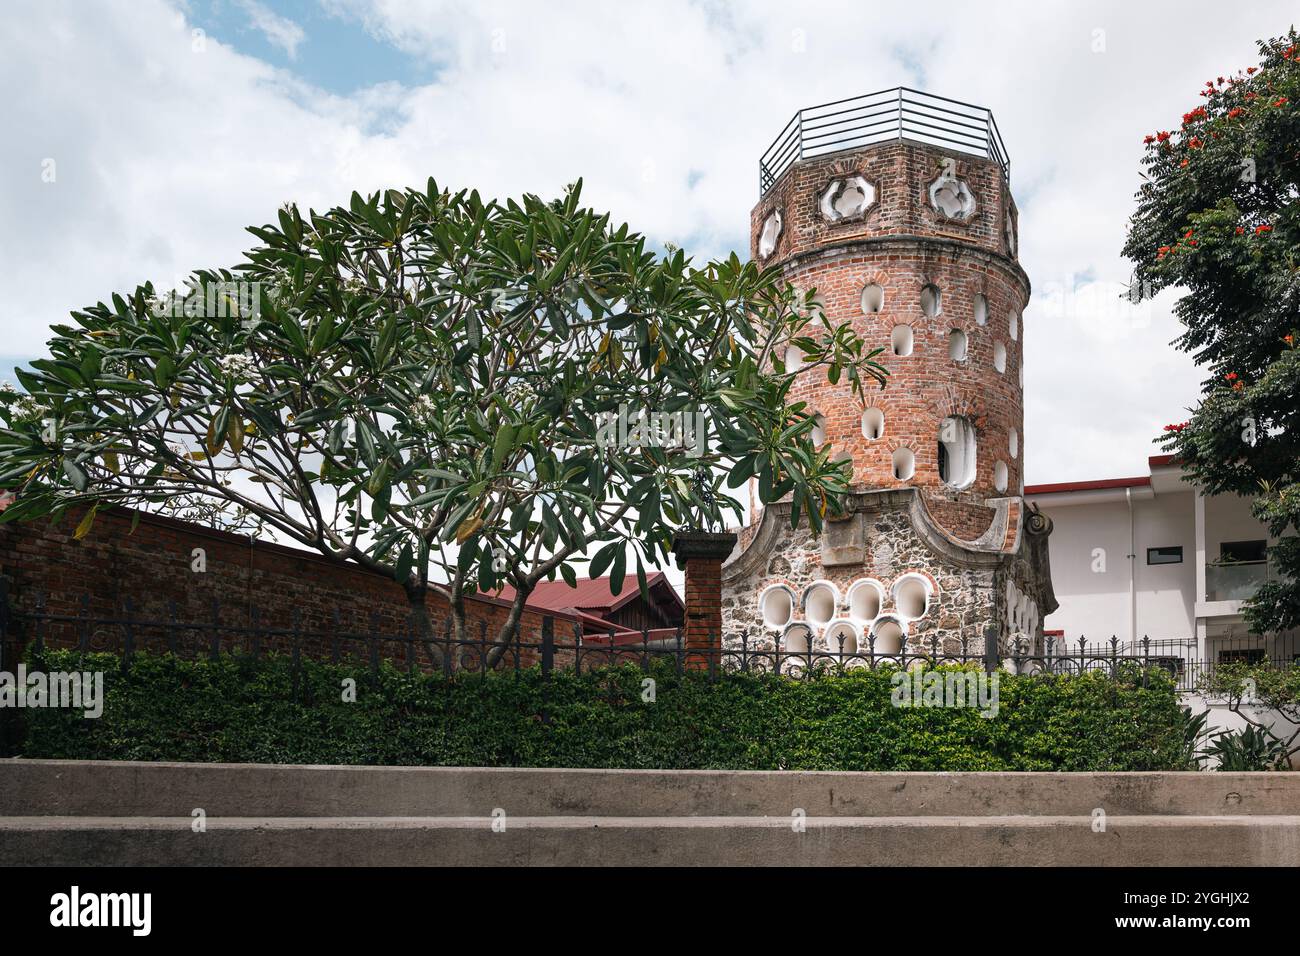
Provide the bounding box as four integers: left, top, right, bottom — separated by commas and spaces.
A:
1024, 455, 1300, 764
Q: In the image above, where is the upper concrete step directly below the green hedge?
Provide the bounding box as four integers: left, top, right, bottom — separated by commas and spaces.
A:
0, 760, 1300, 817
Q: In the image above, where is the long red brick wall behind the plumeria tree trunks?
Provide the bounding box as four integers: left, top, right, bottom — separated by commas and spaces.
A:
0, 509, 575, 665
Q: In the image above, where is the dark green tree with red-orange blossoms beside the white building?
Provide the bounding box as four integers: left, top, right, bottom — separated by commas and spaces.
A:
1125, 29, 1300, 631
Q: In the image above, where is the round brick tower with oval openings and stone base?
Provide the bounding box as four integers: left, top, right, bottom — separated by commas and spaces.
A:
723, 88, 1057, 654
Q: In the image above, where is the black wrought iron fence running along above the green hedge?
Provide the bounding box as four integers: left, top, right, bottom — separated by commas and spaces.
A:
0, 590, 1300, 691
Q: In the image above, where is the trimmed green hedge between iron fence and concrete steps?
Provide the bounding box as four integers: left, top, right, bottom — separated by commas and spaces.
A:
10, 650, 1188, 770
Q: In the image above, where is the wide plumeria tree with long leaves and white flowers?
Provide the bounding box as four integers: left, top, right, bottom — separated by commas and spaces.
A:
0, 181, 885, 652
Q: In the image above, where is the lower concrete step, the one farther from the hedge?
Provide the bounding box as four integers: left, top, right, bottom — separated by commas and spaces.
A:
0, 816, 1300, 866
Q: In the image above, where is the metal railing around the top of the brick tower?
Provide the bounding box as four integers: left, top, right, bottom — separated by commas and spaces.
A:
758, 86, 1011, 195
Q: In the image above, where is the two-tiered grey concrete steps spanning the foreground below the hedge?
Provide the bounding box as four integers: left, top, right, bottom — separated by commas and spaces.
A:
0, 761, 1300, 866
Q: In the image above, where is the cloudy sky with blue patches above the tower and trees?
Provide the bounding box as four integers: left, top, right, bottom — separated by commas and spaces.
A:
0, 0, 1295, 496
